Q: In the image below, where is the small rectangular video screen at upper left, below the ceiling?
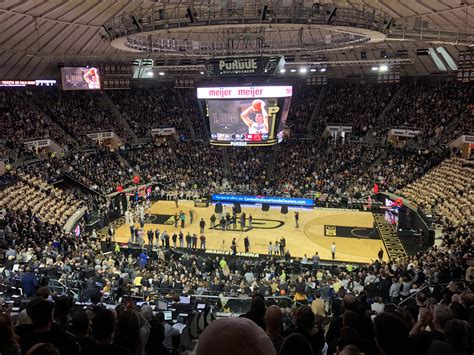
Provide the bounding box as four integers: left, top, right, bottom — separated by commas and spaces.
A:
61, 67, 101, 90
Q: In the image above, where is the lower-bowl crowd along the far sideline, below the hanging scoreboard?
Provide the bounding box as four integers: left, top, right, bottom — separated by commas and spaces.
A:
6, 139, 452, 204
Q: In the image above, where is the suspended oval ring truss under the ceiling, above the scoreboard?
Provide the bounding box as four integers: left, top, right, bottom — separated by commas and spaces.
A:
105, 2, 389, 56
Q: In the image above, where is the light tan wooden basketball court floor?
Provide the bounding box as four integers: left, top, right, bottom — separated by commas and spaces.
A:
115, 201, 388, 263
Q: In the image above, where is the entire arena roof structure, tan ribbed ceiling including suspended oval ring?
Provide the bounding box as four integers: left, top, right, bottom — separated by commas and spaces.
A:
0, 0, 474, 79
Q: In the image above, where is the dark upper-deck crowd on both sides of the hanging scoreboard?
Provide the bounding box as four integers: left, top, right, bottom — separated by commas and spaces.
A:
1, 81, 474, 151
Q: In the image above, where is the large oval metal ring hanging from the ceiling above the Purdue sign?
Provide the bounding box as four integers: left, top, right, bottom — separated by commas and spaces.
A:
105, 1, 388, 56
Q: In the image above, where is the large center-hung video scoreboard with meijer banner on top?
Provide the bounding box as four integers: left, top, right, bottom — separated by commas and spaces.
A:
197, 86, 292, 146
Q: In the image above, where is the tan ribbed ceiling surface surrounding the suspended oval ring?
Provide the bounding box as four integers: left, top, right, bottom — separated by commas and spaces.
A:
0, 0, 474, 80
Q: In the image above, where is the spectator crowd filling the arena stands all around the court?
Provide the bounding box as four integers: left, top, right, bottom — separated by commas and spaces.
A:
0, 82, 474, 355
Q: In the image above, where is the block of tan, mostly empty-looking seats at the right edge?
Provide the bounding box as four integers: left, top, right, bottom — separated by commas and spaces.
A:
398, 158, 474, 226
